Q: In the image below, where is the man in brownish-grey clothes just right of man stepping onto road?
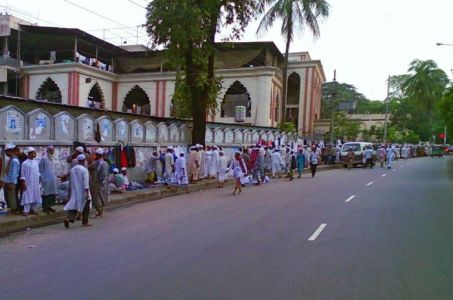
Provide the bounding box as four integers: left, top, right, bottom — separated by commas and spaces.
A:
88, 148, 109, 217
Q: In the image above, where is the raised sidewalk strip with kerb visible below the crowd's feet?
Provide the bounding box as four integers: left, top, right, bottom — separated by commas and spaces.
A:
0, 164, 342, 237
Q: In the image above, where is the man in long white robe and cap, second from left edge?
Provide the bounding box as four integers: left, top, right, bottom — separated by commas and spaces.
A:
20, 147, 41, 216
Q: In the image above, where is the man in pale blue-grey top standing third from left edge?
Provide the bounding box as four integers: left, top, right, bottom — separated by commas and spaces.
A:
39, 146, 57, 213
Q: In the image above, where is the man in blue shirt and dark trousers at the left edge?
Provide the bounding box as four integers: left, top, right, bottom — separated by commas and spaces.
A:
3, 144, 20, 214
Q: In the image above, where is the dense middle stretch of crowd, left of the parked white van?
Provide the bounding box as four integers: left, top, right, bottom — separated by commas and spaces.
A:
145, 144, 321, 195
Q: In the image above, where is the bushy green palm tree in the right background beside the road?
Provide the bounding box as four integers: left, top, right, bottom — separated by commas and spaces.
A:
402, 59, 449, 140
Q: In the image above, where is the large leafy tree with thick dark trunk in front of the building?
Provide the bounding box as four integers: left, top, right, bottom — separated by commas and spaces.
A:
146, 0, 256, 144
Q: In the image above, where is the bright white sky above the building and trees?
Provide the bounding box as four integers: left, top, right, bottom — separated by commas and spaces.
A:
0, 0, 453, 100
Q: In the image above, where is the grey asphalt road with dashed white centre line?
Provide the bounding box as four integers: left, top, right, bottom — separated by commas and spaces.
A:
0, 158, 453, 300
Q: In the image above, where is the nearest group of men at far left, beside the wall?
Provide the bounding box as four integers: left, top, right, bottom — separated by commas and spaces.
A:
0, 144, 129, 227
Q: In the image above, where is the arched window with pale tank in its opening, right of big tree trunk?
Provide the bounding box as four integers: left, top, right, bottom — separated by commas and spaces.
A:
220, 81, 252, 118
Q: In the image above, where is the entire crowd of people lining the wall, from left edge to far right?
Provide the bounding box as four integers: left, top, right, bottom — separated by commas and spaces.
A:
0, 144, 424, 227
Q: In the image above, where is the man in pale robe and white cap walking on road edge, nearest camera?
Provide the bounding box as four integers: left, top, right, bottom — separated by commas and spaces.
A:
64, 154, 91, 228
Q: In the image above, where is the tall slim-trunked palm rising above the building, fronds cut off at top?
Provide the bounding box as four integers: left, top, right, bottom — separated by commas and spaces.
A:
257, 0, 330, 123
